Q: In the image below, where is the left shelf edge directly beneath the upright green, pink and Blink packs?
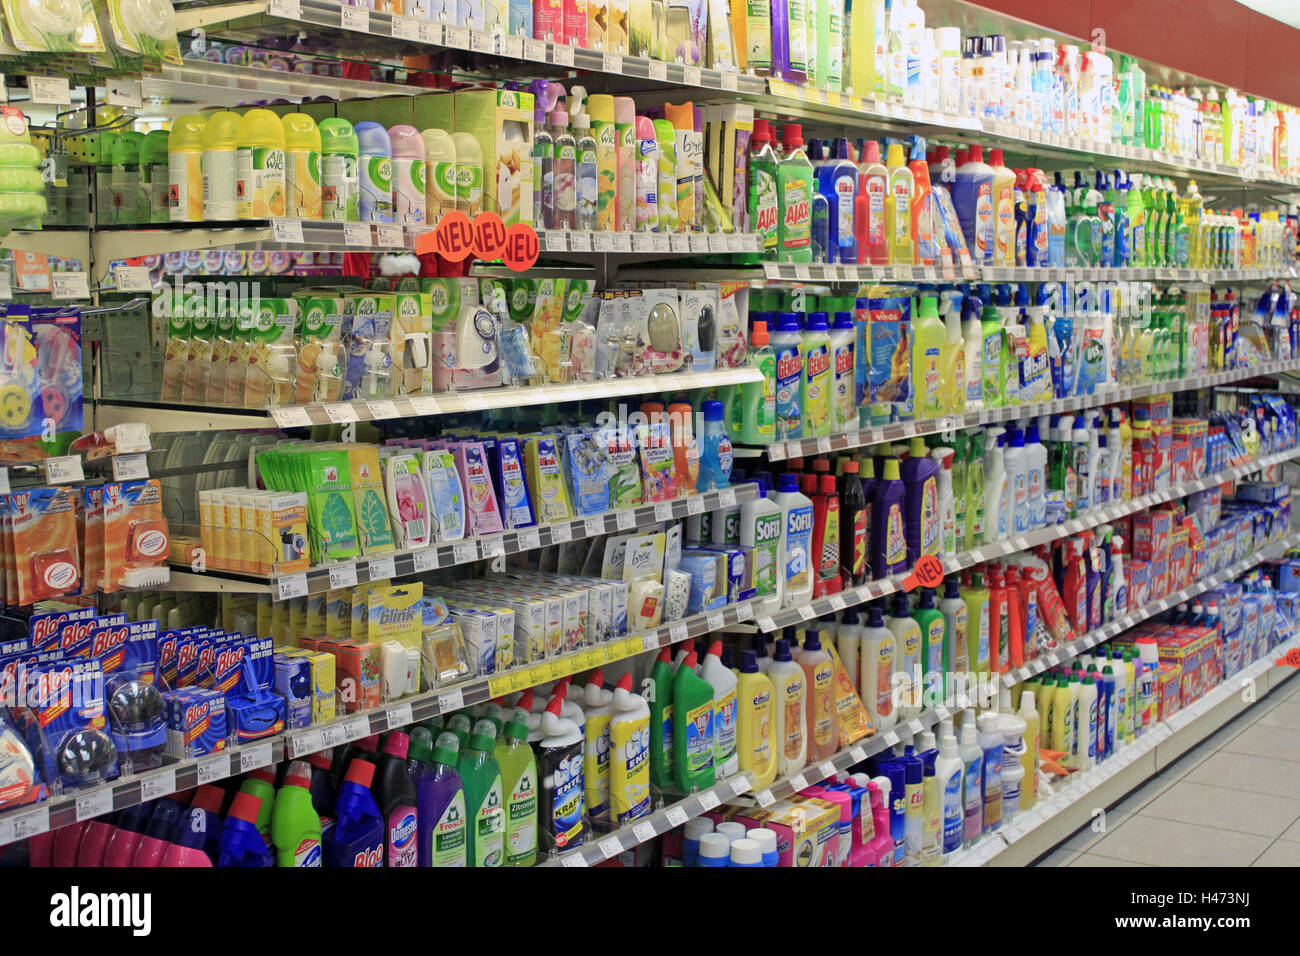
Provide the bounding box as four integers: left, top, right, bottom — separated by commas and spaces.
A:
178, 483, 758, 600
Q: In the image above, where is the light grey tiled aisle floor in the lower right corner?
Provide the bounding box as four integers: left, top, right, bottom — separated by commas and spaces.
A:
1036, 678, 1300, 866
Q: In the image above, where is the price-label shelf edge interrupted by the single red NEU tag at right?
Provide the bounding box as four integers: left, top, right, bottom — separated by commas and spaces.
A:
755, 445, 1300, 633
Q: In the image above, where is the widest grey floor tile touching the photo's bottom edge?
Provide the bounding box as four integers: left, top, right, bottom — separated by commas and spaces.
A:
1089, 814, 1271, 866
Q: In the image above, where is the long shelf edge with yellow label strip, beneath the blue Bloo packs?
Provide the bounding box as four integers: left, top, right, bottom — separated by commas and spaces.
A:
0, 590, 754, 847
